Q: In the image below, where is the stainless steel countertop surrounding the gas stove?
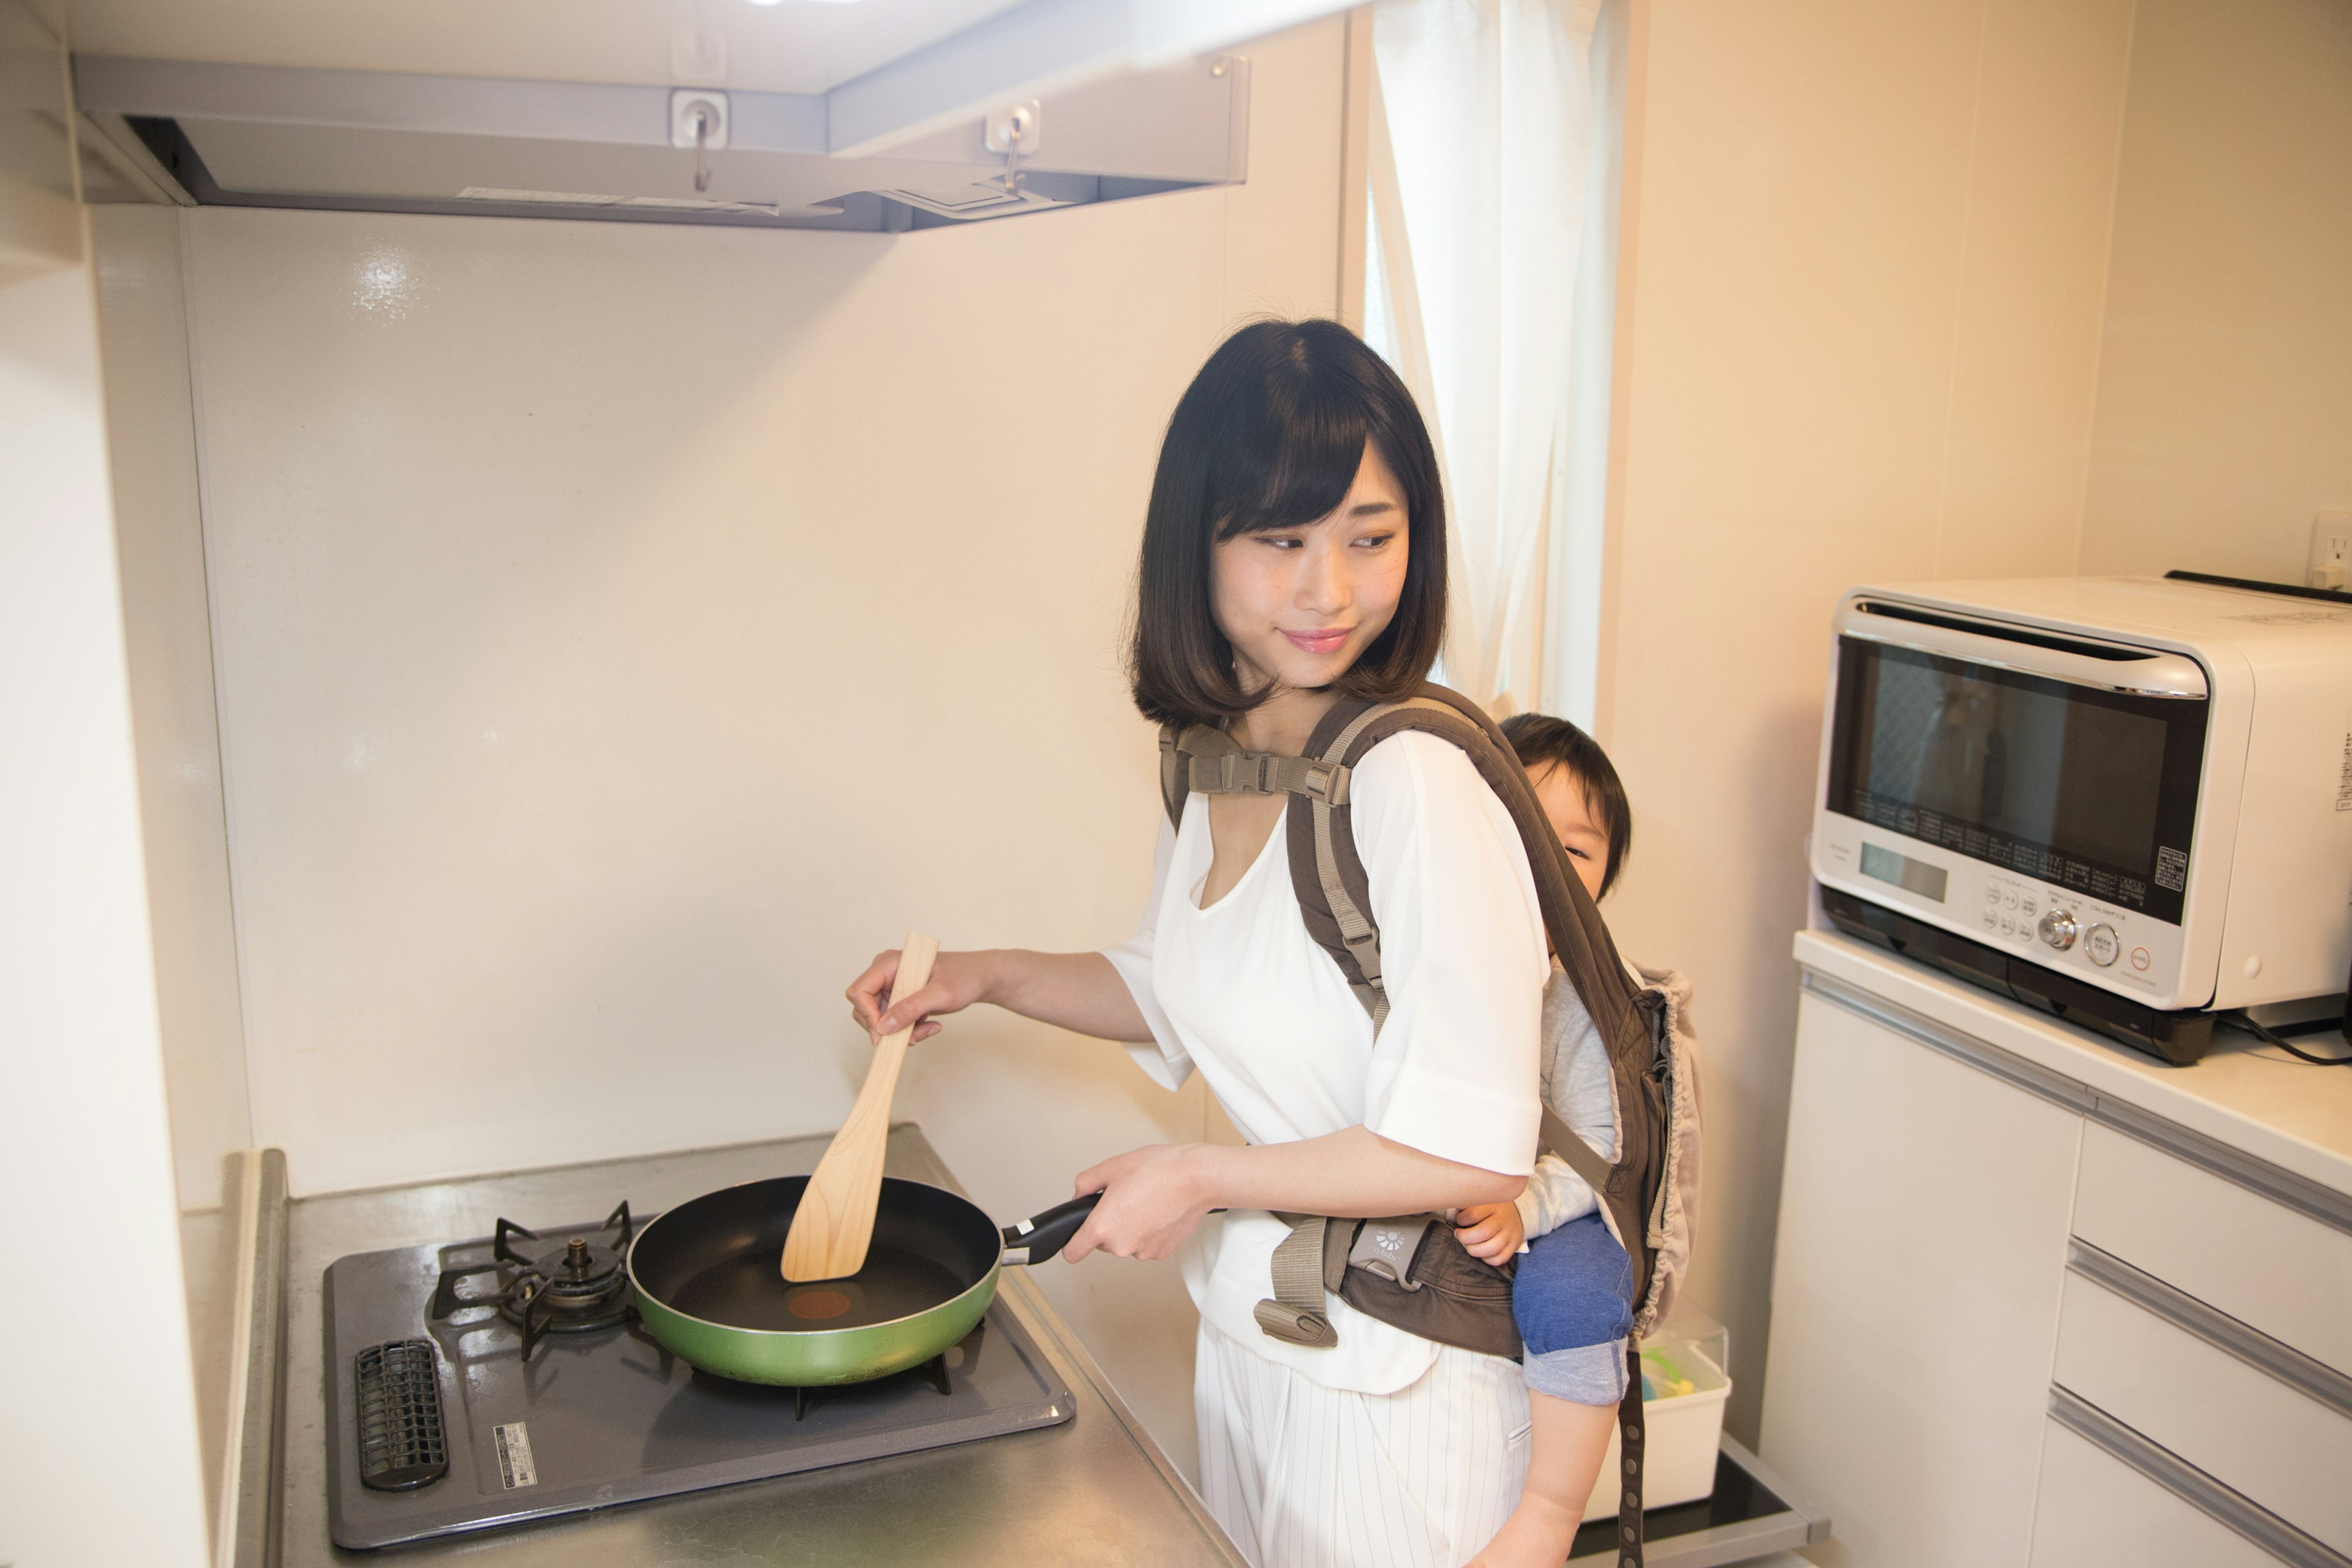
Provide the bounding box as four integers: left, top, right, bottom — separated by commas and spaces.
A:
277, 1124, 1244, 1568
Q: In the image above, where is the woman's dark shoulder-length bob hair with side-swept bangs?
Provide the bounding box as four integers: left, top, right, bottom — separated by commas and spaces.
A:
1126, 322, 1447, 724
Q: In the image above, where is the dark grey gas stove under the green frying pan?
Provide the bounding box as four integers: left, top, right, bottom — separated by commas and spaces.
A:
322, 1201, 1077, 1547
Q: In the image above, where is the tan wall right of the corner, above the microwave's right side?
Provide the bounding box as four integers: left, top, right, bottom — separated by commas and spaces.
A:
2081, 0, 2352, 583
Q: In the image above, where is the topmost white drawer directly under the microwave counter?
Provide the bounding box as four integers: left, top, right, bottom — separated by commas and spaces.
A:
2075, 1121, 2352, 1375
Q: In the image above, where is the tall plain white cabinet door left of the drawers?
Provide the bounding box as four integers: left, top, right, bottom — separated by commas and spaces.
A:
1764, 973, 2081, 1568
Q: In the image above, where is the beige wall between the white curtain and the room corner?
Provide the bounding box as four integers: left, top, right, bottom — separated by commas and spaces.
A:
1597, 0, 2131, 1436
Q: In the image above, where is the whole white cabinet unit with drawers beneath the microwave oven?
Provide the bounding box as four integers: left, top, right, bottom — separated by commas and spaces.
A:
1759, 931, 2352, 1568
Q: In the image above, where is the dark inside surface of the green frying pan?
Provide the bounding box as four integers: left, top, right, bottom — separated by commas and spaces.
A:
633, 1175, 1002, 1333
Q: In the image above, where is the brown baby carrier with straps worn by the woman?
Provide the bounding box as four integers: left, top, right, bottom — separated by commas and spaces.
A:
1159, 684, 1698, 1568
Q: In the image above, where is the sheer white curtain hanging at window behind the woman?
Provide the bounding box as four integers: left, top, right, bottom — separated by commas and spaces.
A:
1366, 0, 1599, 717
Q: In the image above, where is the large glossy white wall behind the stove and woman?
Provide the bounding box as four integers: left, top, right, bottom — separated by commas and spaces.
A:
106, 19, 1343, 1462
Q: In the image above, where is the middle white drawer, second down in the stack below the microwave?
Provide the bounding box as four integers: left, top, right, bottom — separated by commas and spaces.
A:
2053, 1256, 2352, 1551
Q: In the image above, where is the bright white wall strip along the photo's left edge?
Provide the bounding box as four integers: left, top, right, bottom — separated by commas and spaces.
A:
0, 34, 207, 1568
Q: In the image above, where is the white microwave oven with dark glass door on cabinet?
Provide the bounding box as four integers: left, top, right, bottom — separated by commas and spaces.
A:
1811, 578, 2352, 1063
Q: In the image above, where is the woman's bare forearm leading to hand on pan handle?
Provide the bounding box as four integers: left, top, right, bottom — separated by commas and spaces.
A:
1193, 1126, 1526, 1218
